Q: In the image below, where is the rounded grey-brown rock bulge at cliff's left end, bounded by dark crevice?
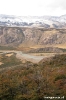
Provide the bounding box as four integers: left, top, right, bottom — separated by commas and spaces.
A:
0, 27, 25, 45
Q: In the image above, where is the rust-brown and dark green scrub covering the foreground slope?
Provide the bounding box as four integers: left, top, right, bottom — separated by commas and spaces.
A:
0, 54, 66, 100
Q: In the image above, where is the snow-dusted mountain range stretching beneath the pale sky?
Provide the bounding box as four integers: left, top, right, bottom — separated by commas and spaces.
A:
0, 14, 66, 28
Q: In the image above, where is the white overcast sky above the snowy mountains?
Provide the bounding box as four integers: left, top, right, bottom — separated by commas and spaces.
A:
0, 0, 66, 16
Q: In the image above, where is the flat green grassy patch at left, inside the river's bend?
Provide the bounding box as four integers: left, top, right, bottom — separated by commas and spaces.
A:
0, 53, 22, 68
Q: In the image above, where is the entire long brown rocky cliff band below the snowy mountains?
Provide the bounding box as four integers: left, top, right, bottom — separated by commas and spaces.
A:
0, 27, 66, 45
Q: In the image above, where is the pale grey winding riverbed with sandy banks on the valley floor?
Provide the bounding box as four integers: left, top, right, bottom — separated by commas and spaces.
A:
0, 50, 54, 63
